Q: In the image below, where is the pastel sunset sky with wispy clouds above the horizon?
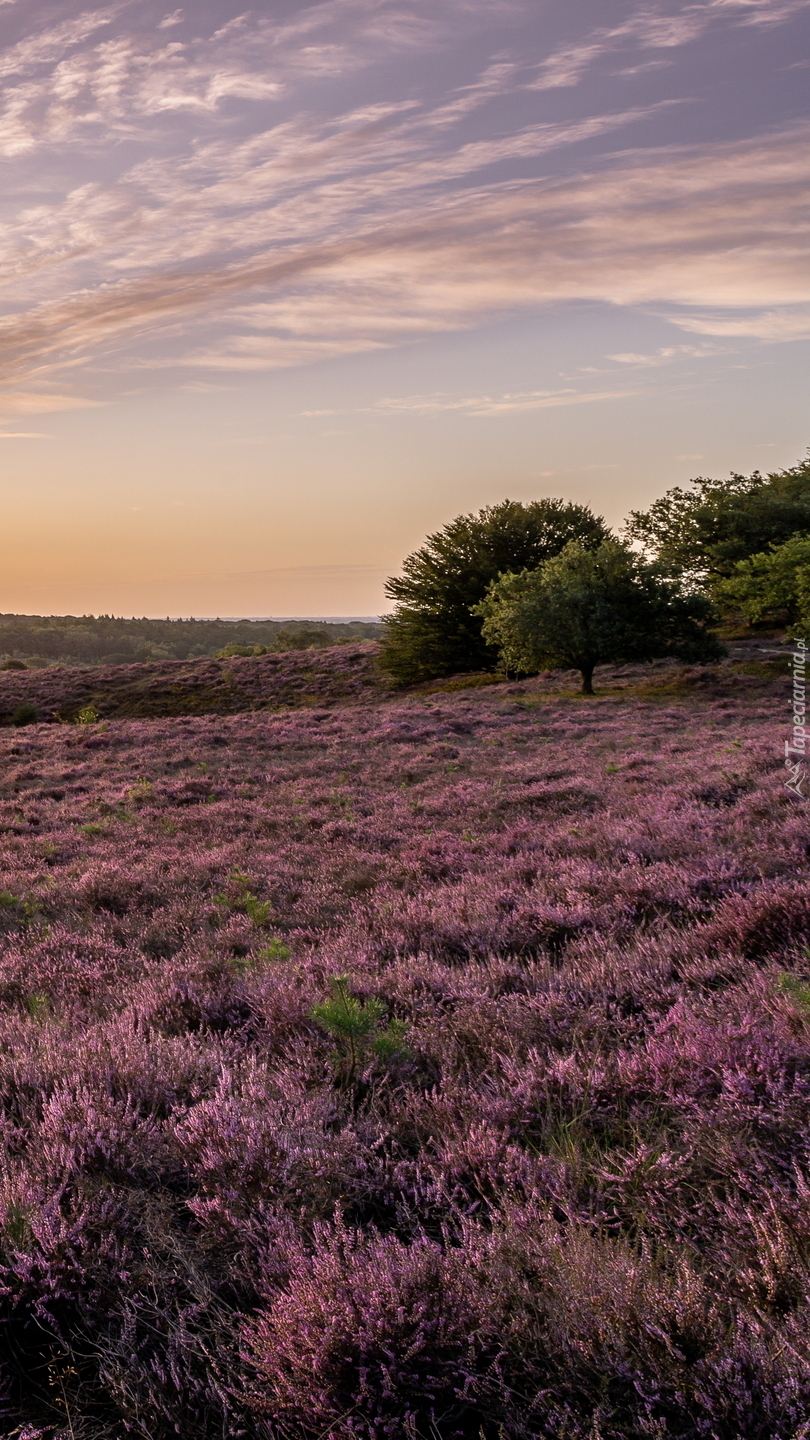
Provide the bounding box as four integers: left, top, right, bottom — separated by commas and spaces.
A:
0, 0, 810, 616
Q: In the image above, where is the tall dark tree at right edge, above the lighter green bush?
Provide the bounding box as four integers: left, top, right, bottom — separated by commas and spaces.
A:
626, 458, 810, 586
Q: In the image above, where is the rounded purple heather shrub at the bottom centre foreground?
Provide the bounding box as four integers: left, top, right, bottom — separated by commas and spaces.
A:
244, 1224, 494, 1440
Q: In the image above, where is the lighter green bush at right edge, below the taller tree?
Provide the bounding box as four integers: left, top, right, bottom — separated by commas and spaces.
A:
713, 534, 810, 628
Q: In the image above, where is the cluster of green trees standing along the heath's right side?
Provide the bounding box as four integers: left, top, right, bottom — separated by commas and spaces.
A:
380, 459, 810, 694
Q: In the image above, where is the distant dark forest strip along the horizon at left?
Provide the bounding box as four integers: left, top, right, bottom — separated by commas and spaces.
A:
0, 615, 382, 667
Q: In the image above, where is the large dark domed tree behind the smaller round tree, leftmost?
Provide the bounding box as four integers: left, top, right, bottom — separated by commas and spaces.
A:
380, 500, 608, 684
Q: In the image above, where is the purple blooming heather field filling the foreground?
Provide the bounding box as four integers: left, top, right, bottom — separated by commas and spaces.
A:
0, 647, 810, 1440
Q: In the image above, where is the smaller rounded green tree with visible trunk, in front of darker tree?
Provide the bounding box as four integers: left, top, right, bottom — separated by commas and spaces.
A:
476, 540, 724, 696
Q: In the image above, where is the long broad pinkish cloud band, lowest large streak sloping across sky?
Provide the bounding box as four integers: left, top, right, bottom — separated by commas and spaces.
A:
0, 120, 810, 403
